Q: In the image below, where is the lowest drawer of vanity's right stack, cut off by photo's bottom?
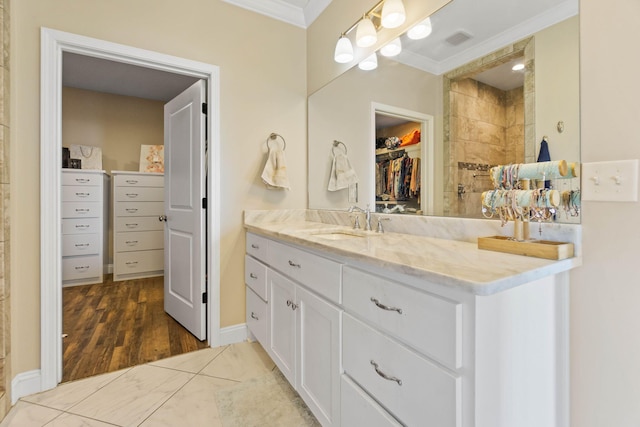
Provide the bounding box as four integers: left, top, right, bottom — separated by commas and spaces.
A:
340, 375, 402, 427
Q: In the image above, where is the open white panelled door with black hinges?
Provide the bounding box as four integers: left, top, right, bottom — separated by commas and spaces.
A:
161, 80, 207, 340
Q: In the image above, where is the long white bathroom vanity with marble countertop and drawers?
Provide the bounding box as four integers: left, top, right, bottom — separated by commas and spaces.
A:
245, 211, 580, 427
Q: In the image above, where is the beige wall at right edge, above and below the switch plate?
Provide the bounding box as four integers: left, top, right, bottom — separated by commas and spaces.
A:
571, 0, 640, 427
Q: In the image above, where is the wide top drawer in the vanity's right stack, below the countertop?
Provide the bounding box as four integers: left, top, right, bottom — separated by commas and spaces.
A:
342, 267, 462, 369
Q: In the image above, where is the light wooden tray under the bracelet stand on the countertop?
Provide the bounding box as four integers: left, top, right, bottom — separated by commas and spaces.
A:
478, 236, 573, 260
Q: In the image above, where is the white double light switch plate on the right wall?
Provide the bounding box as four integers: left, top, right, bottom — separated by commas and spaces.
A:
581, 159, 638, 202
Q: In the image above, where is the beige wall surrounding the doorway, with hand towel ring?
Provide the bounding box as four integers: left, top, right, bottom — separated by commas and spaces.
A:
11, 0, 307, 377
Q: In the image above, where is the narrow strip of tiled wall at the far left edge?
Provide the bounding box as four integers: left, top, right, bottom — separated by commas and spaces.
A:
0, 0, 11, 419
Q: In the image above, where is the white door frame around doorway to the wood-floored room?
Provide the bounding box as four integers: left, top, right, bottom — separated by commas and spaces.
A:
40, 27, 221, 391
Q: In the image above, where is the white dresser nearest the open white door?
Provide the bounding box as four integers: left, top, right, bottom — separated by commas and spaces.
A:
112, 171, 164, 281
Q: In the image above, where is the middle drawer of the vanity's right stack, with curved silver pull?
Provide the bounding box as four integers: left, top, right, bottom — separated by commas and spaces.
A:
342, 314, 461, 427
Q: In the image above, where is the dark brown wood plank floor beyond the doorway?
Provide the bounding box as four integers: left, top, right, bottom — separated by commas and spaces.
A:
62, 275, 206, 382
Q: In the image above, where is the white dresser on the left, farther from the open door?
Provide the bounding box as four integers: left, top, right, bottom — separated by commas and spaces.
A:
62, 169, 109, 286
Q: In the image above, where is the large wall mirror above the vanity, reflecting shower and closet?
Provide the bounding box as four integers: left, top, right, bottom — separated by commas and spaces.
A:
308, 0, 580, 222
